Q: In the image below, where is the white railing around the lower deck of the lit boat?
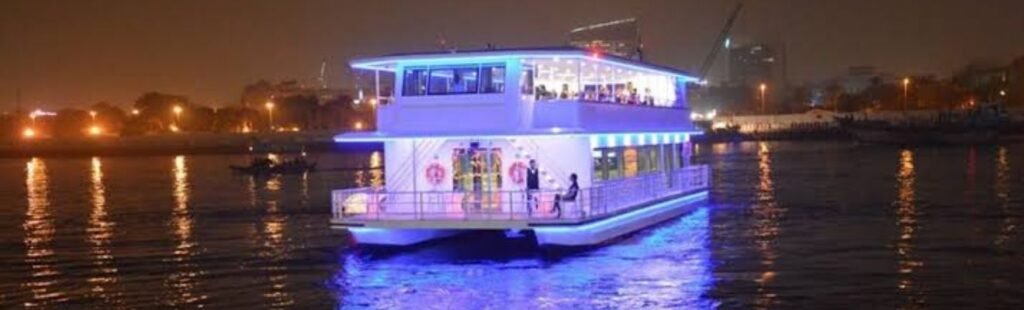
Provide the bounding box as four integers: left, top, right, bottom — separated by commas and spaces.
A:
332, 166, 711, 223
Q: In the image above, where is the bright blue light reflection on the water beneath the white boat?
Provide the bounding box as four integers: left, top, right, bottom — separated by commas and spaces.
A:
333, 208, 715, 309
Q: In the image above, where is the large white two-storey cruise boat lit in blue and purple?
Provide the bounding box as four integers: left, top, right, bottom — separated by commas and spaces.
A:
330, 47, 711, 247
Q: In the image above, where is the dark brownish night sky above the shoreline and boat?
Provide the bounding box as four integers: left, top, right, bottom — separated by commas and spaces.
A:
0, 0, 1024, 109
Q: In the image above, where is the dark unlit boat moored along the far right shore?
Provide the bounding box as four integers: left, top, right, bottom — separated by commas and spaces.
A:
836, 105, 1022, 145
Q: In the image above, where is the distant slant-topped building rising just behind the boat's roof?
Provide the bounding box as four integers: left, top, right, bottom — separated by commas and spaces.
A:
568, 18, 643, 59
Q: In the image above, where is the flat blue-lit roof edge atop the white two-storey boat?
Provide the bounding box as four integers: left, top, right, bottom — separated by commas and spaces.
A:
349, 46, 698, 81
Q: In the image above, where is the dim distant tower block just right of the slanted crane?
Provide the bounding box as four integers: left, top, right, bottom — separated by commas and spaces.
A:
729, 44, 778, 85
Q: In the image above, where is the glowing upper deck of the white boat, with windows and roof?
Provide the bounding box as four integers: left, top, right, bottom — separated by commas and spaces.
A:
351, 48, 695, 134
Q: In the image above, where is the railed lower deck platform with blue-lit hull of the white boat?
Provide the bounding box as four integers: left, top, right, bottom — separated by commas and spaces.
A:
331, 166, 710, 246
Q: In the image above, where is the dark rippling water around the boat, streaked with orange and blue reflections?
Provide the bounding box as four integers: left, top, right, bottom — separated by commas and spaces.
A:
0, 142, 1024, 309
